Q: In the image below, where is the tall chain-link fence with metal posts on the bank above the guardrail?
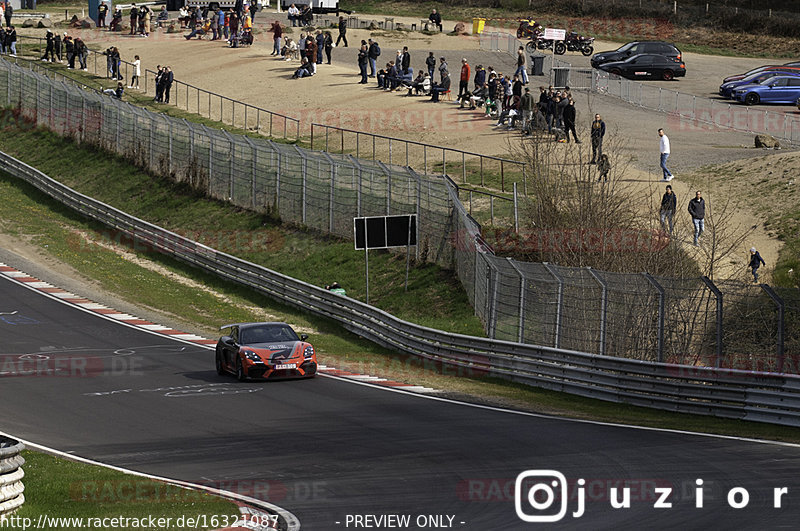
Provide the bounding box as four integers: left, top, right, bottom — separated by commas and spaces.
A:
0, 59, 800, 373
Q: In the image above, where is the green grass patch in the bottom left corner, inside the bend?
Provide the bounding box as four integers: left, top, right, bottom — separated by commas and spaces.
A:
16, 450, 239, 530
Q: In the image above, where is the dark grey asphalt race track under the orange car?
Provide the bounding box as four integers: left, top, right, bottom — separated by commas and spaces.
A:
0, 279, 800, 531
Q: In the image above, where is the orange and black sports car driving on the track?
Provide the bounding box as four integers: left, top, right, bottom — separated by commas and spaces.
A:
216, 323, 317, 381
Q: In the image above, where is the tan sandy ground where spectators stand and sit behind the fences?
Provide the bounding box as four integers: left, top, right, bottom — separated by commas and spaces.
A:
15, 16, 794, 280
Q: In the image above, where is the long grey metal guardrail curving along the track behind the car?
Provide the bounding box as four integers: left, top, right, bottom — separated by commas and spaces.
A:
0, 149, 800, 426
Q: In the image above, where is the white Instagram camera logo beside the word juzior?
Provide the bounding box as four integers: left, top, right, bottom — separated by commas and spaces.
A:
514, 470, 568, 522
